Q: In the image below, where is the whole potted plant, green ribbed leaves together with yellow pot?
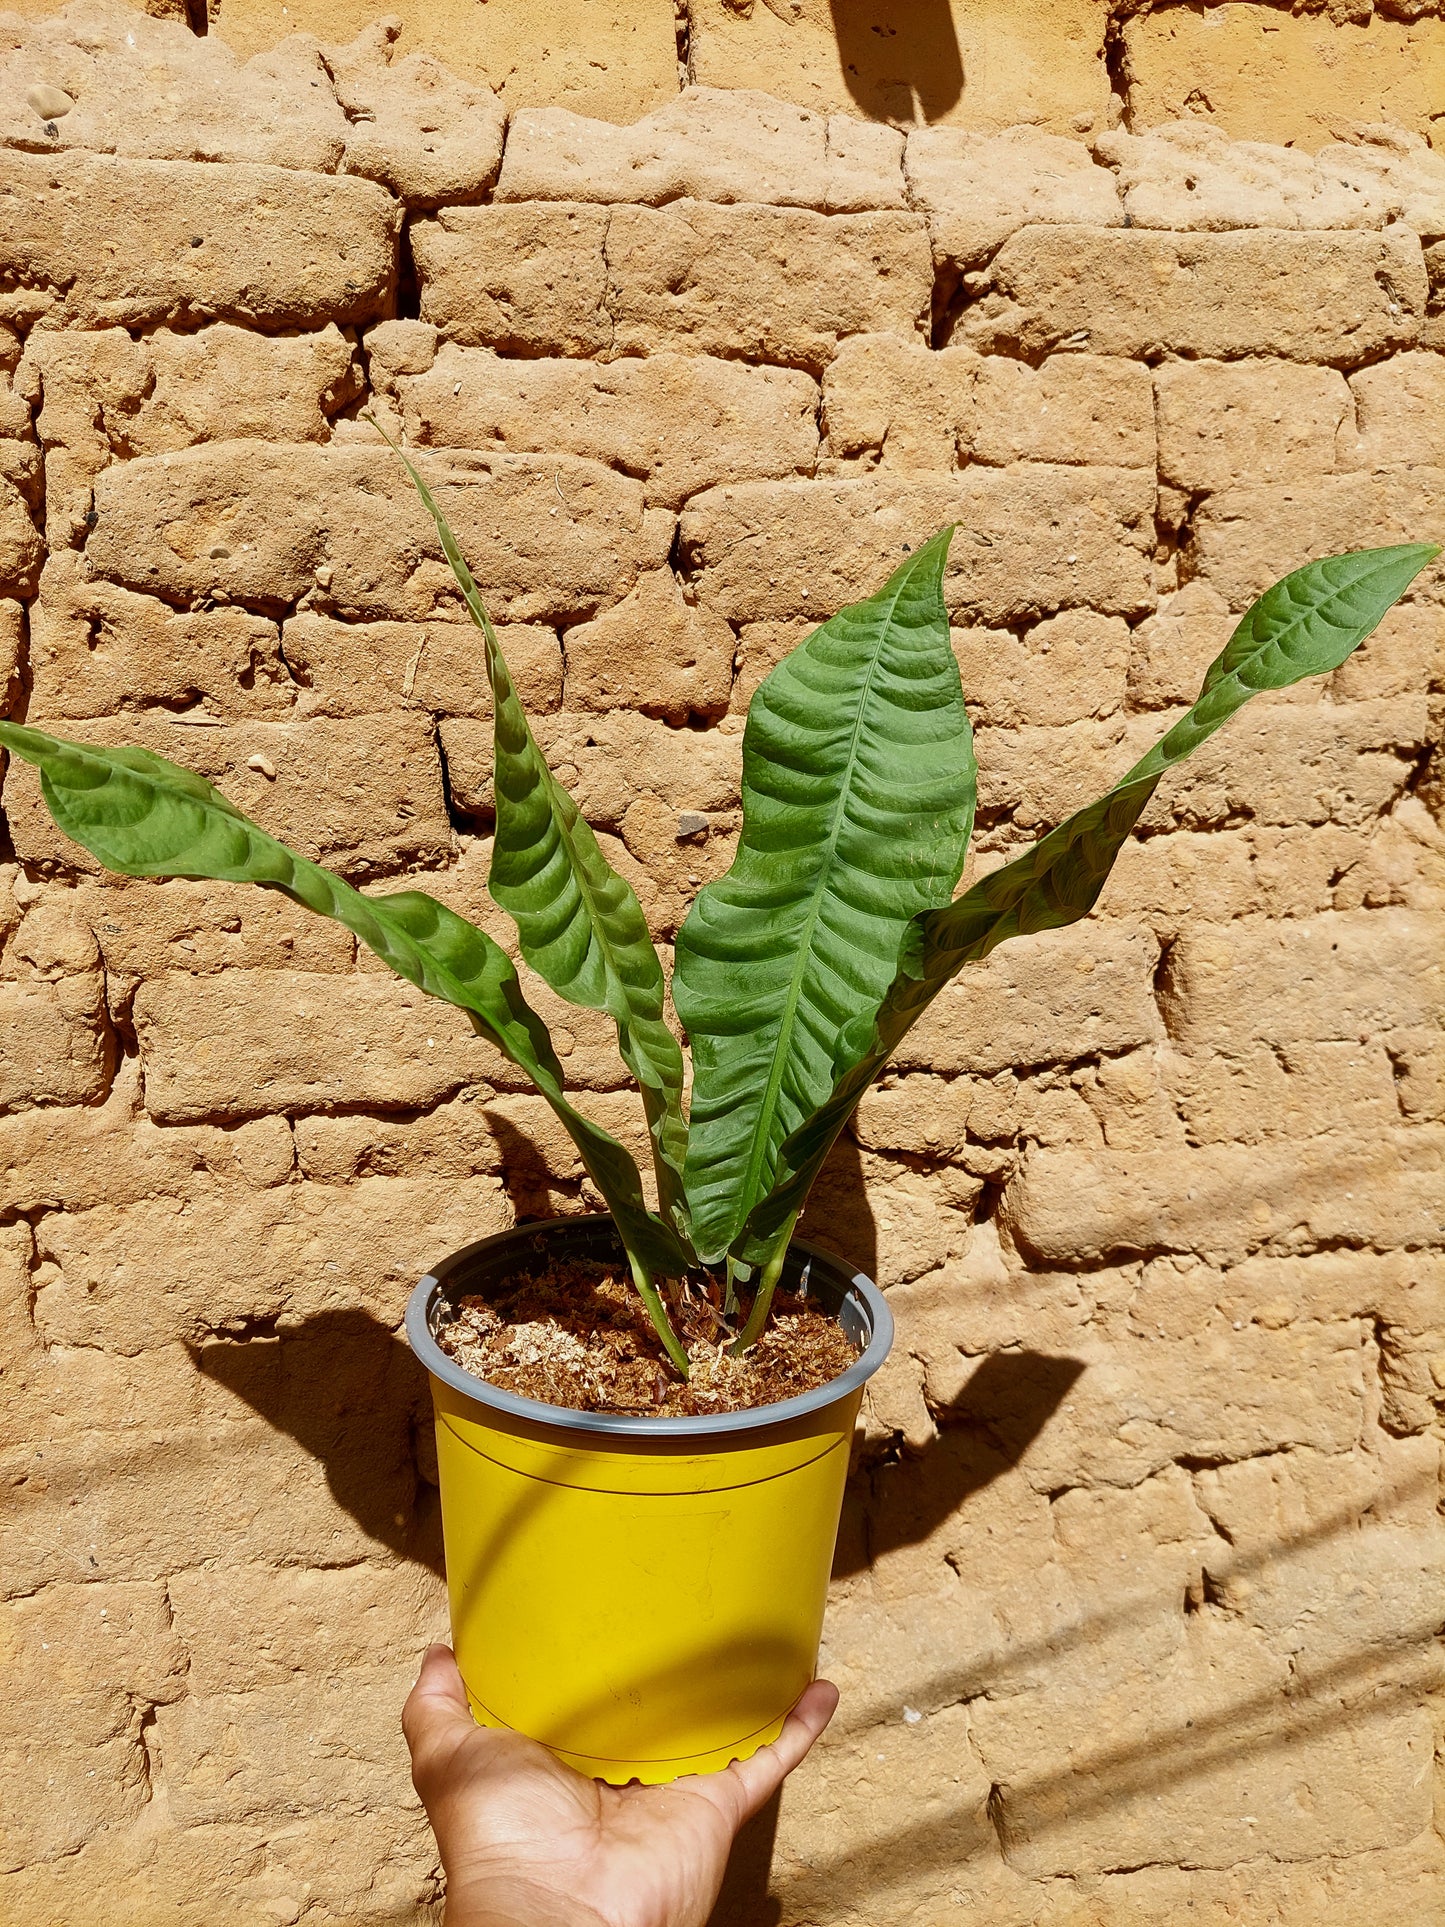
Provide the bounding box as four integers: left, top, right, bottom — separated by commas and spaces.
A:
0, 457, 1439, 1782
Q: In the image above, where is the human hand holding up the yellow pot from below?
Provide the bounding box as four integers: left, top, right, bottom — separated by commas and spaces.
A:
401, 1646, 838, 1927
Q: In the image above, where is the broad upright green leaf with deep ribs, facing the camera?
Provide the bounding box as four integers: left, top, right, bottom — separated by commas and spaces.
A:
672, 528, 975, 1262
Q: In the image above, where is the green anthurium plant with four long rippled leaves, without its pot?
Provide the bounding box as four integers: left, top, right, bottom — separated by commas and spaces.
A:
0, 457, 1439, 1376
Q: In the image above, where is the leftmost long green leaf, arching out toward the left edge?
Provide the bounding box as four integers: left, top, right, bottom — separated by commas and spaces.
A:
0, 723, 688, 1276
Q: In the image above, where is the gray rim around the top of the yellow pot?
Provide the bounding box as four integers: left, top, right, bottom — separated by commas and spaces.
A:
407, 1212, 894, 1443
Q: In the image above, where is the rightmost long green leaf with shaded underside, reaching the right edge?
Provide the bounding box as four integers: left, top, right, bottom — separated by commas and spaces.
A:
736, 543, 1441, 1262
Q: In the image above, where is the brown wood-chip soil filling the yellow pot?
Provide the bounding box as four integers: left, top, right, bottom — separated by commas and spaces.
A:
437, 1258, 857, 1418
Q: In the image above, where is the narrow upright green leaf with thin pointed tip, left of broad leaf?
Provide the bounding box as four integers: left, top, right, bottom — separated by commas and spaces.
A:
369, 437, 688, 1239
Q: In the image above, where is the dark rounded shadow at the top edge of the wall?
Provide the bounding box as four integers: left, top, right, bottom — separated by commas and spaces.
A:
824, 0, 963, 125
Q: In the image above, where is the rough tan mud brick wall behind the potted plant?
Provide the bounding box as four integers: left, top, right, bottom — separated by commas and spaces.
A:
0, 6, 1445, 1927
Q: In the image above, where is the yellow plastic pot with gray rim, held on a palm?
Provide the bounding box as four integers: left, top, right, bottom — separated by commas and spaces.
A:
407, 1218, 892, 1784
